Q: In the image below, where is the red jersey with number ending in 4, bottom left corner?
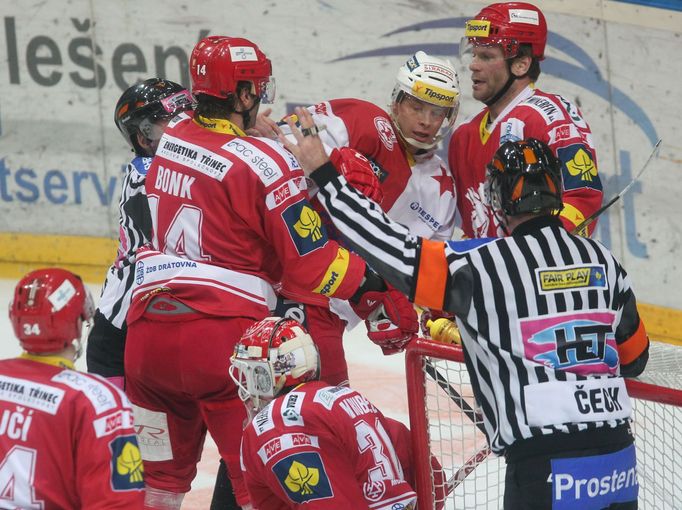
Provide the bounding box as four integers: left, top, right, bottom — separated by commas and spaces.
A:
0, 355, 144, 510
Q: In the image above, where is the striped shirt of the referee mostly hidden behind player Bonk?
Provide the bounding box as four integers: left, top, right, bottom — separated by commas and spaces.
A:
99, 156, 152, 329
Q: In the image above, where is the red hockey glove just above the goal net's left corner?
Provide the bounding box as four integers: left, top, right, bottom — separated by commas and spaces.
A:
353, 289, 419, 355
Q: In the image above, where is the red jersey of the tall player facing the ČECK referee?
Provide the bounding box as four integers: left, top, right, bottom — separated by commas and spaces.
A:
448, 87, 603, 238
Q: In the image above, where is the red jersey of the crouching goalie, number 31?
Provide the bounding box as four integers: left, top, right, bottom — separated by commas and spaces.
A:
242, 382, 416, 510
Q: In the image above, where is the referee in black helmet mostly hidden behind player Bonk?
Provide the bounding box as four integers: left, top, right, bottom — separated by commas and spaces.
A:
87, 78, 194, 389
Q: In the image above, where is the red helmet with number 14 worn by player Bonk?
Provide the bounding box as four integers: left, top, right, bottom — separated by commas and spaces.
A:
189, 35, 275, 103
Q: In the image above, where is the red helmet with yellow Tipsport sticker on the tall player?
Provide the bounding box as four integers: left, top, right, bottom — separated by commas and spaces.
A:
463, 2, 547, 60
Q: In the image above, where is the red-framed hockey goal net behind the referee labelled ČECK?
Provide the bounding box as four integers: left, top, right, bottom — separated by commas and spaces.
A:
405, 339, 682, 510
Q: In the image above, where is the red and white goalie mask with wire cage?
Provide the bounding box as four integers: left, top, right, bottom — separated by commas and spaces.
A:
230, 317, 320, 409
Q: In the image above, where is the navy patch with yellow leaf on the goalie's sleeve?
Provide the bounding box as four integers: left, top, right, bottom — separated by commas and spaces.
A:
272, 452, 334, 504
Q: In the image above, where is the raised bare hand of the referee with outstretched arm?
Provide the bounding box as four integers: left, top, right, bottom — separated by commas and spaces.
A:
275, 106, 329, 175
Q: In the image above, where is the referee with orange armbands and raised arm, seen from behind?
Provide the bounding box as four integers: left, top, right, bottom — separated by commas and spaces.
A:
281, 108, 649, 510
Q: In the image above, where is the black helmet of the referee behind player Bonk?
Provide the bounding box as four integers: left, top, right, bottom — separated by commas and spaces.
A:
114, 78, 194, 156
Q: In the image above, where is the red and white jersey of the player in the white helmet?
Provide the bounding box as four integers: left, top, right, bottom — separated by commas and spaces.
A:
308, 99, 456, 240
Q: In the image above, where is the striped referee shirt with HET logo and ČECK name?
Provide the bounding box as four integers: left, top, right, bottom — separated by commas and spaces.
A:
311, 163, 648, 453
